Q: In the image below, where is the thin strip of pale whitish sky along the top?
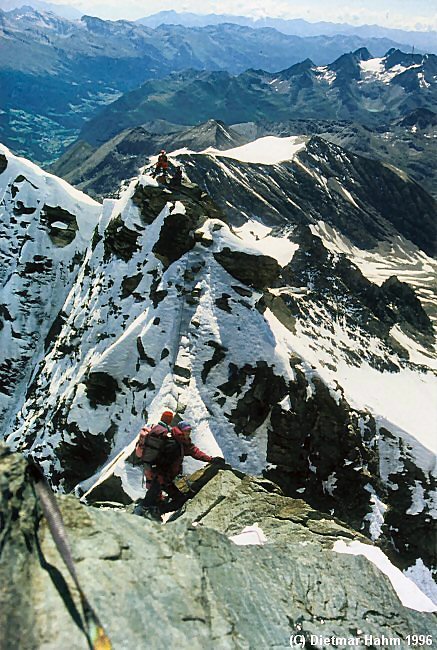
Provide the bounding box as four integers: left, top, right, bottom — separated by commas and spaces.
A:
48, 0, 437, 31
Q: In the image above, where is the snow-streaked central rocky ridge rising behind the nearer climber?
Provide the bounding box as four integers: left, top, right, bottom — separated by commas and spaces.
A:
0, 138, 437, 584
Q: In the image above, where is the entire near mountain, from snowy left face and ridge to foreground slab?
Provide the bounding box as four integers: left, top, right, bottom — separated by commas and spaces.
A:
0, 126, 437, 650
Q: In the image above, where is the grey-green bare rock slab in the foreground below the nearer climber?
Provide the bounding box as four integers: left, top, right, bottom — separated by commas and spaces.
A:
0, 448, 434, 650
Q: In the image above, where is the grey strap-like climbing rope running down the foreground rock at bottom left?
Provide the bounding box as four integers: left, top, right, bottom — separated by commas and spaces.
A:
29, 464, 112, 650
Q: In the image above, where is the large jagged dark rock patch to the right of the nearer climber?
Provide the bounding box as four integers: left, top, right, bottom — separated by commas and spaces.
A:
266, 368, 378, 528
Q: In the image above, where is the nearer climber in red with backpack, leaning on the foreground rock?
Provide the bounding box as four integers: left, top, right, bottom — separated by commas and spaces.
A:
134, 411, 224, 521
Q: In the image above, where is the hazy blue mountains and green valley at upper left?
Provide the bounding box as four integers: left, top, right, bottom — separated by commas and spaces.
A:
0, 7, 414, 164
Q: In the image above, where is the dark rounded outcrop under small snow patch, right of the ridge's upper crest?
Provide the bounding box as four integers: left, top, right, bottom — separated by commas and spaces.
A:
214, 248, 281, 289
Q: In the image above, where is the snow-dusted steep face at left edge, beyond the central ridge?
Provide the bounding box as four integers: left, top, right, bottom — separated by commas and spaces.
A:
0, 147, 101, 430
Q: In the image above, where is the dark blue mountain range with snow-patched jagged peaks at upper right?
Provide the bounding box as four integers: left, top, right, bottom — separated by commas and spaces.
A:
80, 48, 437, 146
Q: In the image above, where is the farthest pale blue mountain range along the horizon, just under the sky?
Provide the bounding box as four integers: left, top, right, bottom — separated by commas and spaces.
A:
136, 10, 437, 54
